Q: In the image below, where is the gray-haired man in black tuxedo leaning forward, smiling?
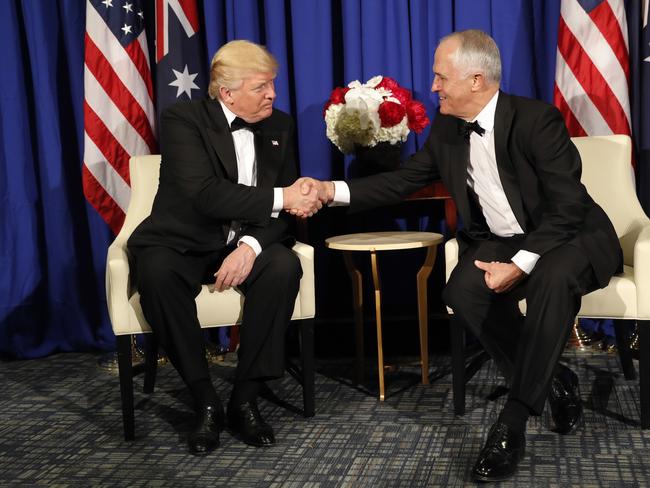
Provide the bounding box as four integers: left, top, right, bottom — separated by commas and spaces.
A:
302, 30, 622, 481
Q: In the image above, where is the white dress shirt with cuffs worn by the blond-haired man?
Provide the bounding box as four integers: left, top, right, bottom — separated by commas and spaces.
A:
219, 100, 284, 256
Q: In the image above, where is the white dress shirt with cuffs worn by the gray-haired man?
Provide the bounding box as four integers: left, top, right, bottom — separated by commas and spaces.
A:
332, 92, 540, 274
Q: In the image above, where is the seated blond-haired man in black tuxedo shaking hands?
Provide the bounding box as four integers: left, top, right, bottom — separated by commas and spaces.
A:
128, 41, 321, 455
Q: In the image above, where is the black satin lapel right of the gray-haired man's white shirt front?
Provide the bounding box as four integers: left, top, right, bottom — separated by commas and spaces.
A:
494, 96, 526, 232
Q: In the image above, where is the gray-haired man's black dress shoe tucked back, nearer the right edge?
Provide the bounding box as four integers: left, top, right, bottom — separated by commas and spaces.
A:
548, 365, 582, 434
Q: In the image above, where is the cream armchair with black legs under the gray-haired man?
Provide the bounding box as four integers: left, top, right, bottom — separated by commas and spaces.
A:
445, 135, 650, 429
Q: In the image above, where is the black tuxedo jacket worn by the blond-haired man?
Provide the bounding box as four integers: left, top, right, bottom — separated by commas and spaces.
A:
128, 99, 297, 252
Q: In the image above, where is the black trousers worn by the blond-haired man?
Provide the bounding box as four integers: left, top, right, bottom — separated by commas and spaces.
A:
130, 244, 302, 384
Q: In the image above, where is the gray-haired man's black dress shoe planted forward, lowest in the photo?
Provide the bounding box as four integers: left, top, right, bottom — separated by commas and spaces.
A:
473, 421, 526, 481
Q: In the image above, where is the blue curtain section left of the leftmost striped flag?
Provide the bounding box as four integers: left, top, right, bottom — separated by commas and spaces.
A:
0, 1, 114, 357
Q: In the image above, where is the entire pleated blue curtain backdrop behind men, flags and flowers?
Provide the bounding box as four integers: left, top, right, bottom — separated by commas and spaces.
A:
0, 0, 640, 358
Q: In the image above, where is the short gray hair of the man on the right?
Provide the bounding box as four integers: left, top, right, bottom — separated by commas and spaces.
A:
438, 29, 501, 84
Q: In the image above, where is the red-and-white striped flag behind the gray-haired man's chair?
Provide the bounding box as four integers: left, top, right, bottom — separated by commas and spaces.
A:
554, 0, 631, 136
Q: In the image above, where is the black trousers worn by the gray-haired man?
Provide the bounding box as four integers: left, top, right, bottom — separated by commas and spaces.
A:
443, 236, 598, 415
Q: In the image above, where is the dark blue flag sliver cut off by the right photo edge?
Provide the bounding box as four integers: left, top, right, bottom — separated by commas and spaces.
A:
627, 0, 650, 215
